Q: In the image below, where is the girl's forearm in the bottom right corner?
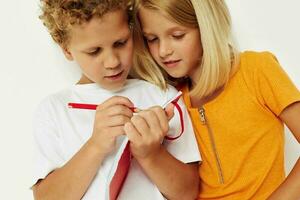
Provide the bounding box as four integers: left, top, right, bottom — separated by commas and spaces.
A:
268, 158, 300, 200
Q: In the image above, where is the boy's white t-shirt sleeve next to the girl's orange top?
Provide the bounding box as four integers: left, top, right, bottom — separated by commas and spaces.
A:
164, 87, 201, 163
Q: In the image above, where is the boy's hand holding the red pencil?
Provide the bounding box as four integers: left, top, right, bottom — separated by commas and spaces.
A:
90, 96, 133, 155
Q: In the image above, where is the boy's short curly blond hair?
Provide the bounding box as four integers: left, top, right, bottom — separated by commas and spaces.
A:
39, 0, 131, 47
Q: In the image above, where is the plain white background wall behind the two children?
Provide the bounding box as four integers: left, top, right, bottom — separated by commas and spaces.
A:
0, 0, 300, 200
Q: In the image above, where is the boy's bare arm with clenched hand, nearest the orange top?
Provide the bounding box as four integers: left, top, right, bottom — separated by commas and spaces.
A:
125, 104, 199, 200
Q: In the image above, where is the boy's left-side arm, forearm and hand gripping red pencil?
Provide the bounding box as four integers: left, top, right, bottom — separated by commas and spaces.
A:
33, 97, 132, 200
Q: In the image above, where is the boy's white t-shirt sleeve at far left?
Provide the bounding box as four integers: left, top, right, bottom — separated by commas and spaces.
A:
31, 99, 64, 187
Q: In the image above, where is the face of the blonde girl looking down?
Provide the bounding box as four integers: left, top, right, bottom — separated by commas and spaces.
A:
139, 7, 202, 80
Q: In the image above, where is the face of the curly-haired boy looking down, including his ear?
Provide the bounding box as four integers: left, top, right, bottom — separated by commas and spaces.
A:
64, 10, 133, 90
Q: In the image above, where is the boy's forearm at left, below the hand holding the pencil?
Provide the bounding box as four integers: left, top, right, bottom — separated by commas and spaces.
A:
33, 141, 104, 200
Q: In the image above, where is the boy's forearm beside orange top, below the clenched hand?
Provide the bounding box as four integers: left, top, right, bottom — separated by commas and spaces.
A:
138, 147, 199, 200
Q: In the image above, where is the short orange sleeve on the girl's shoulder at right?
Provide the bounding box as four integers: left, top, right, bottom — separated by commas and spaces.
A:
256, 52, 300, 116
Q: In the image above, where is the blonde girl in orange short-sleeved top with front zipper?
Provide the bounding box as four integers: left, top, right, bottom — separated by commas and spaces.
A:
135, 0, 300, 200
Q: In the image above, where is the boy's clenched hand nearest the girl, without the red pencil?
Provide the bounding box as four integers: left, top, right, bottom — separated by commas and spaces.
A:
124, 104, 174, 159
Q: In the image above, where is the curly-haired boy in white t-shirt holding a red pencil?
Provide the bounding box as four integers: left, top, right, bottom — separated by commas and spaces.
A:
33, 0, 200, 200
